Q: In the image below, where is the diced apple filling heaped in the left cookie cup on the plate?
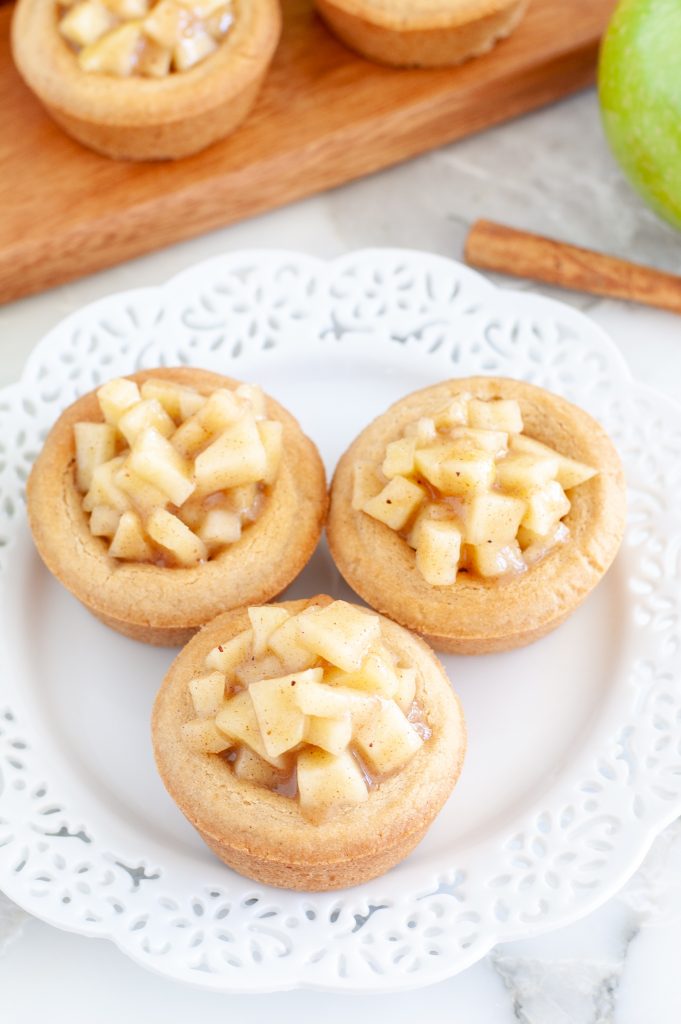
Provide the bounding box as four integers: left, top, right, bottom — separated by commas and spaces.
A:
72, 376, 284, 567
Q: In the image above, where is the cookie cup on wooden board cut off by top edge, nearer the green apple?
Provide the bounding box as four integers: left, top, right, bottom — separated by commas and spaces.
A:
315, 0, 527, 68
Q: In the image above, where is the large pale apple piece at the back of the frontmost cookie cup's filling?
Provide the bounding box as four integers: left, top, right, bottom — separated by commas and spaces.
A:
296, 601, 381, 672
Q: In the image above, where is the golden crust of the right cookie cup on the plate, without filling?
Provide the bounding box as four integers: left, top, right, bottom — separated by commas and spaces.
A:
327, 377, 626, 654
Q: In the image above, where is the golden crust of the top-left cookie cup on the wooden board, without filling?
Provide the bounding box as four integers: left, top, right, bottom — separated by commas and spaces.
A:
12, 0, 282, 160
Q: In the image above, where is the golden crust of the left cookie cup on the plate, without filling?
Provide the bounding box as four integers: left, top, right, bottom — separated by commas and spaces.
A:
27, 367, 327, 646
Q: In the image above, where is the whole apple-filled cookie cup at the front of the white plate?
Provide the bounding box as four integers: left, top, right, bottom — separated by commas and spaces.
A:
152, 596, 466, 890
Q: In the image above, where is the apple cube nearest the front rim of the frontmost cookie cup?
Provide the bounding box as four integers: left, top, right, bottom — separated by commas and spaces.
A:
298, 748, 369, 821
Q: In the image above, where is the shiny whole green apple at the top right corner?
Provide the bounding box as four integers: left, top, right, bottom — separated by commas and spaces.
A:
598, 0, 681, 228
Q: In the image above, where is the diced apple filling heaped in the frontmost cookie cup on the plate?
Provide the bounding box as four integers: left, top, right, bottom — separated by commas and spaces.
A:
182, 601, 430, 821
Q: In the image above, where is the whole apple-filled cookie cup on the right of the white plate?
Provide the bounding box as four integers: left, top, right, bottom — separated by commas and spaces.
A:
327, 377, 626, 654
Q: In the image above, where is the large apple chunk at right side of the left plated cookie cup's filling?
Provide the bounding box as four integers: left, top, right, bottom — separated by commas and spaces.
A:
195, 416, 267, 494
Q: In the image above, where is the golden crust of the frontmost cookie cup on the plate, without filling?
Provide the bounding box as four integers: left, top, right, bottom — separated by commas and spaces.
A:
152, 596, 466, 891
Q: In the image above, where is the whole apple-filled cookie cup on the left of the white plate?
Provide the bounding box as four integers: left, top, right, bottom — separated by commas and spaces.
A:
27, 367, 327, 645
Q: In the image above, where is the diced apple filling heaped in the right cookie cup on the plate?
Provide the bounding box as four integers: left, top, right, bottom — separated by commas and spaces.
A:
360, 393, 597, 587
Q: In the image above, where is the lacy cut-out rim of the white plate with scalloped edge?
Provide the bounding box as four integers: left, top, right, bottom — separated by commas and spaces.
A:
0, 250, 681, 991
